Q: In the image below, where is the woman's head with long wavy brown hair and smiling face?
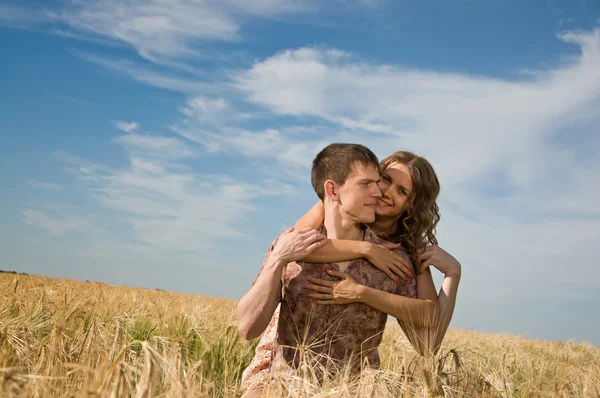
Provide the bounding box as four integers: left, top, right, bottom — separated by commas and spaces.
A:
376, 151, 440, 257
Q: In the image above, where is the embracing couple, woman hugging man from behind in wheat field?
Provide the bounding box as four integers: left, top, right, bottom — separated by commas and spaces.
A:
237, 144, 461, 396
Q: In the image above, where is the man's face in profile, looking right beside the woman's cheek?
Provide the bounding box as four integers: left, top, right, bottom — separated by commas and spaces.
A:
339, 162, 381, 224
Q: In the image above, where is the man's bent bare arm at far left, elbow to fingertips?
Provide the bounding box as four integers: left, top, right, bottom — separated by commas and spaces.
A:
237, 228, 326, 340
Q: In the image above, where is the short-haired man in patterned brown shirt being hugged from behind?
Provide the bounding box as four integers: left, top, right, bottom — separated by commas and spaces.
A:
238, 144, 434, 391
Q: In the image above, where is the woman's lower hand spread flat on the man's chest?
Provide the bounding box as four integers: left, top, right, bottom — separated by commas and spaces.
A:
304, 270, 364, 305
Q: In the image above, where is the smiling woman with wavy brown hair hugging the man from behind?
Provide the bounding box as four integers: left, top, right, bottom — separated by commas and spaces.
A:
296, 151, 461, 355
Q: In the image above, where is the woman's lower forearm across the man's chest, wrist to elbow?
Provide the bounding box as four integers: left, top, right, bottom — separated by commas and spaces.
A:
359, 285, 437, 328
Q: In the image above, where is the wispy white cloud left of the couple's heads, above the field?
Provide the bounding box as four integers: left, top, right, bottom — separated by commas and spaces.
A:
51, 123, 292, 254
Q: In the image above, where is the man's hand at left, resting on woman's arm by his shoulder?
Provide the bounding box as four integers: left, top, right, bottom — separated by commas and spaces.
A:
270, 227, 327, 263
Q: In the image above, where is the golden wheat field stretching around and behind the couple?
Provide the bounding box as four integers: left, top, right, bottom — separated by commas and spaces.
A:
0, 273, 600, 397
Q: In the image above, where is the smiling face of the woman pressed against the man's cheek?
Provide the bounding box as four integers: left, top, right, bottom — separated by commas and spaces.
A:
375, 163, 412, 217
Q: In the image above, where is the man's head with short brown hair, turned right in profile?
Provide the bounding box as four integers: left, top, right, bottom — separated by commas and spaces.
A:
311, 144, 381, 223
